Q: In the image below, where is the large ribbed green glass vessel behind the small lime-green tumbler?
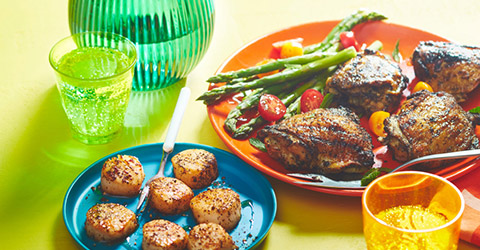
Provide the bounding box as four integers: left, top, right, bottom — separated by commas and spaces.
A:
69, 0, 215, 91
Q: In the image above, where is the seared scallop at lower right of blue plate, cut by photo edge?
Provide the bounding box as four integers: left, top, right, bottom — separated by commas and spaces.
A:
188, 223, 238, 250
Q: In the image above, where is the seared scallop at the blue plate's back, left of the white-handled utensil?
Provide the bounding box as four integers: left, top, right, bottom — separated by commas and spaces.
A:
100, 155, 145, 196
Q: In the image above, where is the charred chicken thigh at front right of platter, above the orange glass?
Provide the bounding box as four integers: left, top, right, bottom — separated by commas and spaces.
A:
379, 90, 479, 163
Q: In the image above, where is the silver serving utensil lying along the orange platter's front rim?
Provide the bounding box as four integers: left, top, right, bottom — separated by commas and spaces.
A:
287, 149, 480, 189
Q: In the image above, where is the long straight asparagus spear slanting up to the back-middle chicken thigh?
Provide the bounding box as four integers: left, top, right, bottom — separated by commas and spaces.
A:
197, 47, 357, 105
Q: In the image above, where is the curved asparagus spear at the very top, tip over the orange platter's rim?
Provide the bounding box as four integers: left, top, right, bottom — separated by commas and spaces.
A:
303, 10, 386, 54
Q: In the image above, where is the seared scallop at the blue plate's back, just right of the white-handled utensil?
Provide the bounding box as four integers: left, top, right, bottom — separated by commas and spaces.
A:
172, 149, 218, 189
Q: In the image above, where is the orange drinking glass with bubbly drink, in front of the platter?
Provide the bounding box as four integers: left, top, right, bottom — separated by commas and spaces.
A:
362, 171, 465, 250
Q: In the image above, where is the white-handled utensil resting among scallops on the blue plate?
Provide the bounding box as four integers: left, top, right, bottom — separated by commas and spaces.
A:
137, 87, 190, 211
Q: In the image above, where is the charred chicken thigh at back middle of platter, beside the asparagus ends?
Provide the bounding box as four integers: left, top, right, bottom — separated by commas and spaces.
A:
326, 49, 409, 115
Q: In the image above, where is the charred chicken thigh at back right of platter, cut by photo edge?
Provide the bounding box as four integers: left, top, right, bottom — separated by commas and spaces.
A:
412, 41, 480, 102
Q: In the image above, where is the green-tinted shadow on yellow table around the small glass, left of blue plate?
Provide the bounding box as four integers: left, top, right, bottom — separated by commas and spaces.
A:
0, 77, 186, 249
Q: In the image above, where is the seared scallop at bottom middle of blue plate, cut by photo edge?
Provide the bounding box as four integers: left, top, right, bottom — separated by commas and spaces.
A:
142, 219, 188, 250
